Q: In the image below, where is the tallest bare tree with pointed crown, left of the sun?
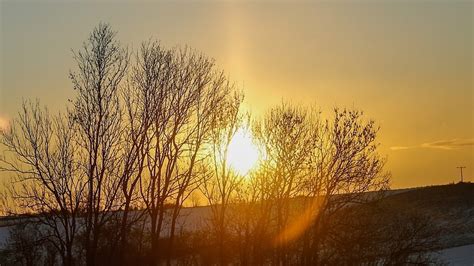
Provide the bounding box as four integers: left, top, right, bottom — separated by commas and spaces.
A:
70, 24, 128, 265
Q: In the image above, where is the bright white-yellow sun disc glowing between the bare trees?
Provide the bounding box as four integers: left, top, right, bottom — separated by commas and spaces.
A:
227, 128, 259, 175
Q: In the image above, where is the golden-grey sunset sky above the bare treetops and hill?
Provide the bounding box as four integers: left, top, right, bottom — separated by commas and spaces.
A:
0, 0, 474, 188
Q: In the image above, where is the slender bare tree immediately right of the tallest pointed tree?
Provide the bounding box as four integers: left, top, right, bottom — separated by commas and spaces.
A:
110, 39, 171, 263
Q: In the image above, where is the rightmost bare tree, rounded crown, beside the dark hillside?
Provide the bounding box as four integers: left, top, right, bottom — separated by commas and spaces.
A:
297, 108, 389, 265
